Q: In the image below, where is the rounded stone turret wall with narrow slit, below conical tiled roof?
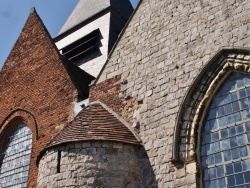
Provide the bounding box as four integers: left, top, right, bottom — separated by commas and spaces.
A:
38, 141, 142, 188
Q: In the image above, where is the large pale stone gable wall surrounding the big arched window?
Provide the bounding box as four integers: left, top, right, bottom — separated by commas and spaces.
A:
97, 0, 250, 188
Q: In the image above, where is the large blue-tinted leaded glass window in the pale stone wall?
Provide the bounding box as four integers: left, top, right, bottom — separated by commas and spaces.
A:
200, 72, 250, 188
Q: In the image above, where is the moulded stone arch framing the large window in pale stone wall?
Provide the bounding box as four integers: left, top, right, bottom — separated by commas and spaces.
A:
173, 48, 250, 162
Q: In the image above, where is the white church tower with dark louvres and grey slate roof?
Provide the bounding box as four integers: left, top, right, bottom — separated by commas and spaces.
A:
54, 0, 133, 77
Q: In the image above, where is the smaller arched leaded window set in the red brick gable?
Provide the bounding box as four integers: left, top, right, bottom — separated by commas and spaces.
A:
0, 124, 32, 188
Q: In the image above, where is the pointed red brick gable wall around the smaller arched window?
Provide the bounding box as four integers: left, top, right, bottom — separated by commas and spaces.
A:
0, 12, 77, 187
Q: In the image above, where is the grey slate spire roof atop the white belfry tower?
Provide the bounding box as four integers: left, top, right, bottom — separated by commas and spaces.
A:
58, 0, 133, 35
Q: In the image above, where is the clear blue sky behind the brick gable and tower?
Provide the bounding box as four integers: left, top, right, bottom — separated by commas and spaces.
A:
0, 0, 139, 68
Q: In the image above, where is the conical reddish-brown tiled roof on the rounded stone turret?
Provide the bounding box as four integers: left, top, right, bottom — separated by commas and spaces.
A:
46, 102, 140, 149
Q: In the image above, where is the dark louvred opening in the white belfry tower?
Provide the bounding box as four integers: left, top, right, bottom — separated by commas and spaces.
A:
61, 29, 101, 62
